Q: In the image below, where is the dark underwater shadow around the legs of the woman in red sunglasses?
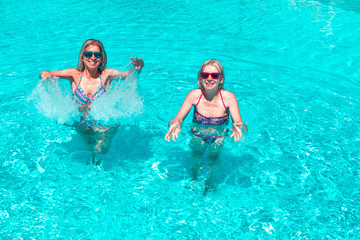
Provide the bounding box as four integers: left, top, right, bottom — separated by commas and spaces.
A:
159, 143, 259, 195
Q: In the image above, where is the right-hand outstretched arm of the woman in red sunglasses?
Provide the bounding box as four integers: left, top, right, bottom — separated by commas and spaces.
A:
226, 92, 247, 142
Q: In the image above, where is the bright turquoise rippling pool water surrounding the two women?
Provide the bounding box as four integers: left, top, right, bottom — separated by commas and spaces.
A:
0, 0, 360, 239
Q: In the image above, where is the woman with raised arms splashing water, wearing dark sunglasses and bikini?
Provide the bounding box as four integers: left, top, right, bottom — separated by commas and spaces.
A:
40, 39, 144, 164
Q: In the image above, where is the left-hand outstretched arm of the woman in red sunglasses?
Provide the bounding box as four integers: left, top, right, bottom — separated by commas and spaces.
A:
165, 90, 196, 142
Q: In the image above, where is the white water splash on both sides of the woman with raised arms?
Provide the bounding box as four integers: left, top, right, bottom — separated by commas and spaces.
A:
29, 71, 143, 125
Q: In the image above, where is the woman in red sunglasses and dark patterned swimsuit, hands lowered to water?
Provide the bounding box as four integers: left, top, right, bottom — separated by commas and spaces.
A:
165, 59, 247, 194
